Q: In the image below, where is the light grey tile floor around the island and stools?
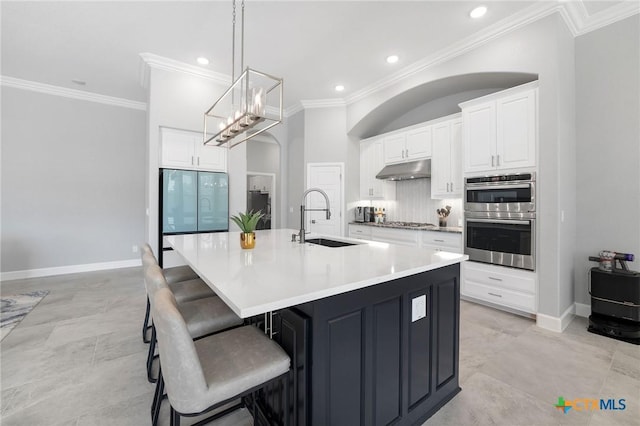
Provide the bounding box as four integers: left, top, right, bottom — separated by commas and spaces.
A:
0, 268, 640, 426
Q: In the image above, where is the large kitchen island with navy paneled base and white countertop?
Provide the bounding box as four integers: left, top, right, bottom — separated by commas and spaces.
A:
166, 229, 466, 425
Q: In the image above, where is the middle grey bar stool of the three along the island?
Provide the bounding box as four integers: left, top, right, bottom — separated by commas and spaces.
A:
144, 265, 244, 383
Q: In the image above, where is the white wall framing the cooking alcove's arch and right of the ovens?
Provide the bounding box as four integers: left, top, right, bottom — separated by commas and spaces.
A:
347, 14, 575, 317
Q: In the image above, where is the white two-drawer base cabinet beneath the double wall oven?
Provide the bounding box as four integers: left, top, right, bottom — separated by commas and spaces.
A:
461, 262, 537, 314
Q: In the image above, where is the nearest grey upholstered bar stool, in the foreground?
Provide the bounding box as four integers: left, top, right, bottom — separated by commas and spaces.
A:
152, 289, 290, 426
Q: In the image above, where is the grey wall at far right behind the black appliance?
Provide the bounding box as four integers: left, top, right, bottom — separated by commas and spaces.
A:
574, 15, 640, 304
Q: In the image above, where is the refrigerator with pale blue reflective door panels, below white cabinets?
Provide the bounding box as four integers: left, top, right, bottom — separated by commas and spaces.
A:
160, 169, 229, 236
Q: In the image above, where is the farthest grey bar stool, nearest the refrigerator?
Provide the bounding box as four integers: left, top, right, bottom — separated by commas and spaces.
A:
141, 244, 215, 343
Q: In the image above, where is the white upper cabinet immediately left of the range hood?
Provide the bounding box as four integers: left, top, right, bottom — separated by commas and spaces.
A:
360, 138, 396, 200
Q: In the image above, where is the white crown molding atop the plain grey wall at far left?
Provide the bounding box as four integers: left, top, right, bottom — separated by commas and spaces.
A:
0, 75, 147, 111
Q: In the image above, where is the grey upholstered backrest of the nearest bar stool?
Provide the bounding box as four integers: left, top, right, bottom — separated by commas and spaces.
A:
151, 288, 207, 413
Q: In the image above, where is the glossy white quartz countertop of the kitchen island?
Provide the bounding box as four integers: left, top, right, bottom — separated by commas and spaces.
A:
165, 229, 468, 318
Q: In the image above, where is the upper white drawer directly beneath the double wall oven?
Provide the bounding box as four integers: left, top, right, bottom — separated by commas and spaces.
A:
463, 262, 536, 294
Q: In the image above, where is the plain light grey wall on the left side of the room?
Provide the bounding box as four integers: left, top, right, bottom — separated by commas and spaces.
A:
0, 86, 146, 275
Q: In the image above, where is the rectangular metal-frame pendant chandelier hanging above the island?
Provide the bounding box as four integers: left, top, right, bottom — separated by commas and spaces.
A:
203, 0, 283, 148
